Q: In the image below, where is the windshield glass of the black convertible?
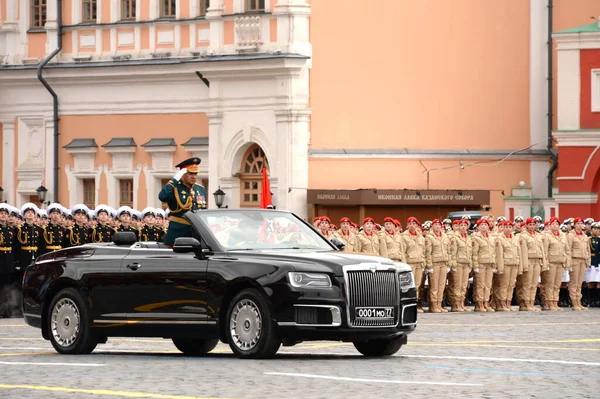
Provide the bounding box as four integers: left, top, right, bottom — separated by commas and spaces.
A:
195, 209, 332, 251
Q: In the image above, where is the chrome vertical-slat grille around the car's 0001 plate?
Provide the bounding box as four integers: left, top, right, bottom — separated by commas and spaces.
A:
346, 270, 400, 327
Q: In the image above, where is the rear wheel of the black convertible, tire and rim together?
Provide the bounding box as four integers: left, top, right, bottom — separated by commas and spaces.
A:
47, 288, 98, 355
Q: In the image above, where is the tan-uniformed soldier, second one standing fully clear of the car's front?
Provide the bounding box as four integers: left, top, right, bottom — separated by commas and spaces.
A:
448, 219, 473, 312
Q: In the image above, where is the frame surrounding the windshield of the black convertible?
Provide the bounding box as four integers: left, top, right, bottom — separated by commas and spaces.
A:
184, 208, 339, 253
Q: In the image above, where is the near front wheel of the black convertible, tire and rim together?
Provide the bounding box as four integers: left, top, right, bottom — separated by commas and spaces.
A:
224, 289, 281, 359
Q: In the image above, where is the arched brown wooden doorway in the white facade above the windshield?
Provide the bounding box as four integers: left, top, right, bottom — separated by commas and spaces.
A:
240, 144, 269, 208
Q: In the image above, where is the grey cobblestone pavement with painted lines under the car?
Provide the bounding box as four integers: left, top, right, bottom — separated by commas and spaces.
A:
0, 309, 600, 399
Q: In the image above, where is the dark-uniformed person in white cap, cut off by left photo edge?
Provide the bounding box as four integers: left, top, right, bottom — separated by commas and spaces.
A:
0, 204, 15, 317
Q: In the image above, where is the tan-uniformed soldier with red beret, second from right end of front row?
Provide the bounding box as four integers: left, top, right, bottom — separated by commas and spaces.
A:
541, 217, 571, 311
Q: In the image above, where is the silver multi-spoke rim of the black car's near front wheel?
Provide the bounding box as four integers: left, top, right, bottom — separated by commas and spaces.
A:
229, 299, 262, 351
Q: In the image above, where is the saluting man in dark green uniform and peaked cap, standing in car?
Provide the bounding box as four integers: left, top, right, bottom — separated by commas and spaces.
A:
158, 158, 206, 245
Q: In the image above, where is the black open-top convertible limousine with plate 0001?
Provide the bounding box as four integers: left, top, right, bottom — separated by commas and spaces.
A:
22, 209, 417, 358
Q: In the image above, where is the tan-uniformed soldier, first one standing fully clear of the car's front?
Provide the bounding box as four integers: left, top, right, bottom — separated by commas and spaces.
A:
425, 219, 451, 313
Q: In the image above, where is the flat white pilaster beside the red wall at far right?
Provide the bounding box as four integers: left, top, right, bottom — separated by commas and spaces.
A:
556, 44, 581, 130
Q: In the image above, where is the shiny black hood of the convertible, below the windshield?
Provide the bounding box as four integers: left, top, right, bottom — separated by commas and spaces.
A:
225, 250, 412, 276
